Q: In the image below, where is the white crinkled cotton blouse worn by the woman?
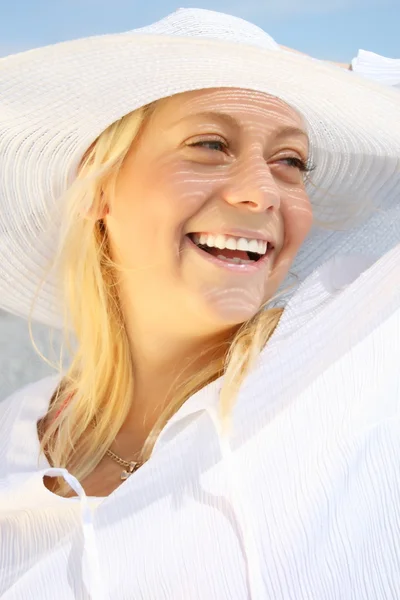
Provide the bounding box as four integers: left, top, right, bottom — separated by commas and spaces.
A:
0, 246, 400, 600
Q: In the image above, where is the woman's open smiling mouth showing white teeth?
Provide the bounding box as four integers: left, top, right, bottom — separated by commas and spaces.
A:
186, 233, 274, 271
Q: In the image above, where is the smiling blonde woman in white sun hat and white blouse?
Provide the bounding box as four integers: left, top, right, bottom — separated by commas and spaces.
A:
0, 5, 400, 600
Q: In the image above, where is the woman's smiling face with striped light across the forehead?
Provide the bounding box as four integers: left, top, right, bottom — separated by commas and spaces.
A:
106, 89, 312, 335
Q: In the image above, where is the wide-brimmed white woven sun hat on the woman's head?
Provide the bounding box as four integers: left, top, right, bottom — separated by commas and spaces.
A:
0, 9, 400, 327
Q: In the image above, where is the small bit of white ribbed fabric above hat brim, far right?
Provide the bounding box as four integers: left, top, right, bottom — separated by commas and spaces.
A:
351, 50, 400, 89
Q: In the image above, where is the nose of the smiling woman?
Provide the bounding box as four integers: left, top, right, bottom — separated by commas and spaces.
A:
224, 158, 281, 212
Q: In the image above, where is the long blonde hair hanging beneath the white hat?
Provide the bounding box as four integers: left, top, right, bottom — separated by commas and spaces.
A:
36, 104, 282, 494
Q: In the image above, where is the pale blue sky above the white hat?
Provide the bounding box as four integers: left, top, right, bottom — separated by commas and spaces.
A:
0, 0, 400, 62
